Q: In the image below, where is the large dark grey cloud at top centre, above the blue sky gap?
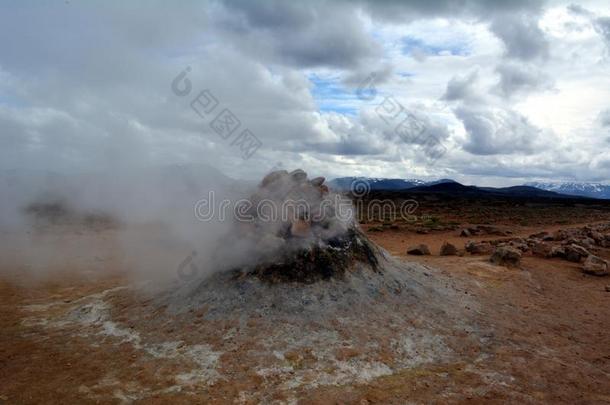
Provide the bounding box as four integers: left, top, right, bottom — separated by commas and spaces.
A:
217, 0, 381, 68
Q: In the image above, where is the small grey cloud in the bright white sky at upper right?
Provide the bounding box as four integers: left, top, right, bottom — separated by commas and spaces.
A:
496, 62, 553, 97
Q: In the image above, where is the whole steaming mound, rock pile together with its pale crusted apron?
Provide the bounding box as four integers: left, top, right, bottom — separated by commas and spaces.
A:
70, 170, 489, 403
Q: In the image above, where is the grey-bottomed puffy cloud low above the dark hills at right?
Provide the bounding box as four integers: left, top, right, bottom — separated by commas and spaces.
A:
455, 106, 542, 155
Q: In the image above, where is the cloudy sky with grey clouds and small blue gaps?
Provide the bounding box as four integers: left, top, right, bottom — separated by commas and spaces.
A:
0, 0, 610, 185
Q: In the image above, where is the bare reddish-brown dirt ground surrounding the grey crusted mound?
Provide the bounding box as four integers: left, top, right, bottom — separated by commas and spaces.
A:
0, 210, 610, 404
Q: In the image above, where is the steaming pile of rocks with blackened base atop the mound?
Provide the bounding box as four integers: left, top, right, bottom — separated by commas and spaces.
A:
224, 169, 380, 283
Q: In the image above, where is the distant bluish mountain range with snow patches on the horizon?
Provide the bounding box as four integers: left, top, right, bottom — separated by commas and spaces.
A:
329, 177, 610, 199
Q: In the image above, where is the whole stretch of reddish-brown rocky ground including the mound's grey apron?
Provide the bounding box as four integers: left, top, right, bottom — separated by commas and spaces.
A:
0, 185, 610, 404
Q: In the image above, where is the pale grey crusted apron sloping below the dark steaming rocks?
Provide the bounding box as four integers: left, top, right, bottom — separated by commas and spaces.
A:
55, 253, 485, 402
